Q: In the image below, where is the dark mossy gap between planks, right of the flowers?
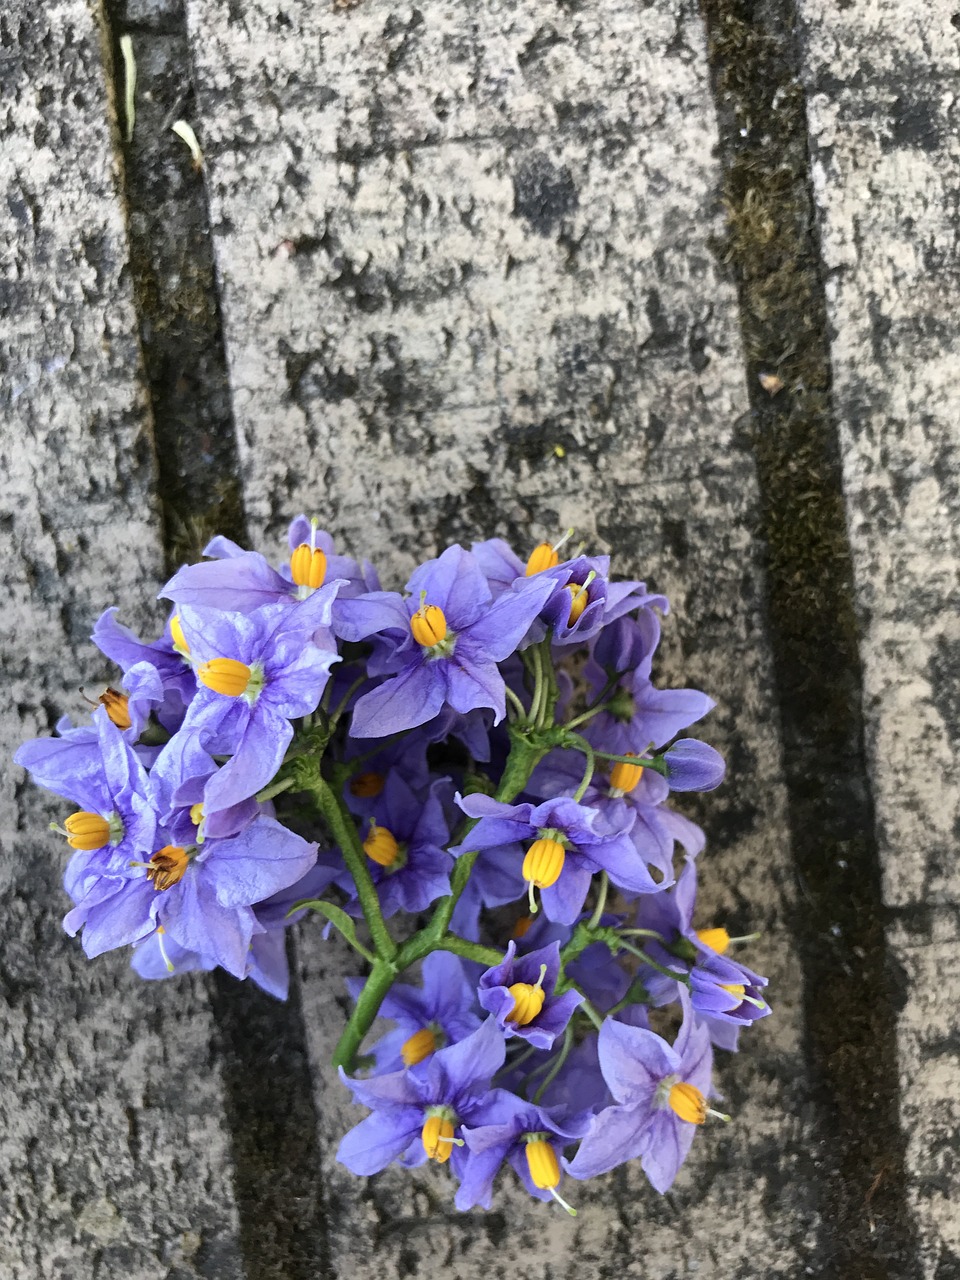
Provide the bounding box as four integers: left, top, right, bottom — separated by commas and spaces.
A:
701, 0, 916, 1280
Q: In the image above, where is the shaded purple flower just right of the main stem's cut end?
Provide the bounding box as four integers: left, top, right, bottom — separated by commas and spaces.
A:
347, 951, 480, 1075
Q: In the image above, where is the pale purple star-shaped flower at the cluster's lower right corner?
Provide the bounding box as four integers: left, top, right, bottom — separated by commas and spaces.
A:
566, 1000, 726, 1192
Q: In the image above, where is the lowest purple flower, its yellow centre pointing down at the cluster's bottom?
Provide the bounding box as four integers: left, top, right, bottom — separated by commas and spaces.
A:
456, 1096, 593, 1213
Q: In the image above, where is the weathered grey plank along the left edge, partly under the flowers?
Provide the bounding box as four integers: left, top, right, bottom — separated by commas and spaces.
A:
0, 0, 241, 1280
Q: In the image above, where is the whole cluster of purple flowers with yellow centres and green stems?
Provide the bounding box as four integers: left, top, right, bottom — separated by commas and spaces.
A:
17, 516, 769, 1212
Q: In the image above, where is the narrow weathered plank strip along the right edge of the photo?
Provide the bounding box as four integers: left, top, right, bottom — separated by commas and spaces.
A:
800, 0, 960, 1276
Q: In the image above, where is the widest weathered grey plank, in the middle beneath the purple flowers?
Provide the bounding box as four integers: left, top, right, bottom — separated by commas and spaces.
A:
188, 0, 815, 1277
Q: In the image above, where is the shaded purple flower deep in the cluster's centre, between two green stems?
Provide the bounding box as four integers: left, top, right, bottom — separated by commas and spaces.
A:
361, 772, 453, 915
